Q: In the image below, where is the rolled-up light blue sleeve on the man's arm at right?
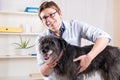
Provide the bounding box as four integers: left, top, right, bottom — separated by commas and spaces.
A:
75, 22, 111, 42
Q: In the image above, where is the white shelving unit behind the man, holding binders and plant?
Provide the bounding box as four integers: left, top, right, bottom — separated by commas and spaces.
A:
0, 0, 44, 80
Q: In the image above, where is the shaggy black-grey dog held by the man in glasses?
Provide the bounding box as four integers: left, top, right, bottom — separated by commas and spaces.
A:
39, 36, 120, 80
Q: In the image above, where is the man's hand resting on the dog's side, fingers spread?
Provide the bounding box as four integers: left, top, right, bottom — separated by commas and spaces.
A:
73, 55, 92, 73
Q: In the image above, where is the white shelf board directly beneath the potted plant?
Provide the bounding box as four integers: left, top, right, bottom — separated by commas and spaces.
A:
0, 55, 36, 59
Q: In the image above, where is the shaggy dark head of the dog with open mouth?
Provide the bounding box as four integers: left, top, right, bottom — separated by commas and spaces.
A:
39, 36, 67, 62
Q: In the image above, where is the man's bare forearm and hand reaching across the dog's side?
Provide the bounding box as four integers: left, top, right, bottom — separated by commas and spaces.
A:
74, 37, 109, 73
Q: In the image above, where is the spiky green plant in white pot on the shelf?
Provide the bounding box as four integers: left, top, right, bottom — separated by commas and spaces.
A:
13, 36, 35, 55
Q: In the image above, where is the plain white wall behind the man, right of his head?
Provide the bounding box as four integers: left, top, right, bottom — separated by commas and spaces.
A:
50, 0, 114, 45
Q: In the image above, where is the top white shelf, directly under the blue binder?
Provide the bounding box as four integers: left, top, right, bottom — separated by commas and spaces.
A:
0, 11, 38, 16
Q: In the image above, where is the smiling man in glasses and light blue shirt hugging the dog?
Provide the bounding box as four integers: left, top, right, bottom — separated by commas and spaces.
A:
36, 1, 111, 80
